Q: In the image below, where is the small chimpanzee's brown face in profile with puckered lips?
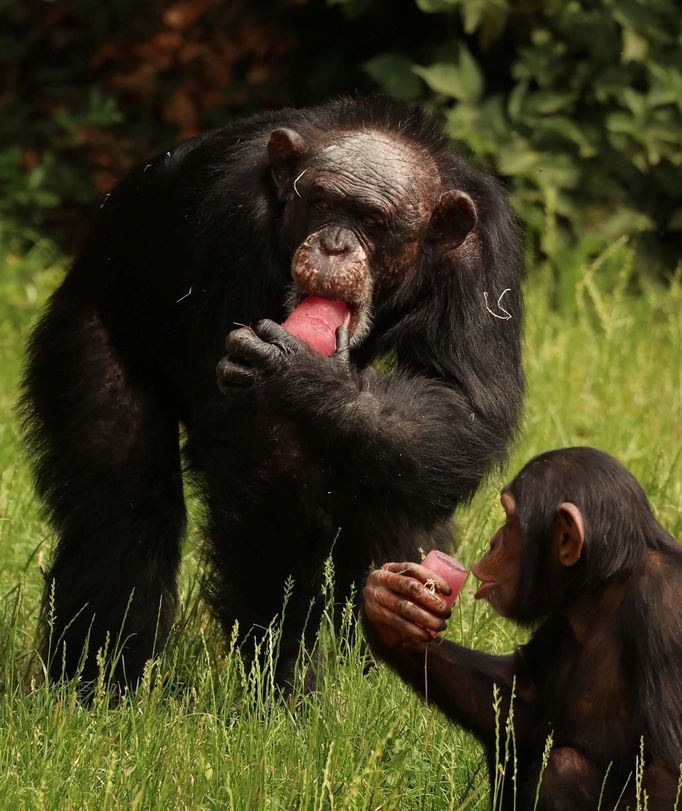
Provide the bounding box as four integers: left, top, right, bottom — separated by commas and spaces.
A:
471, 490, 524, 617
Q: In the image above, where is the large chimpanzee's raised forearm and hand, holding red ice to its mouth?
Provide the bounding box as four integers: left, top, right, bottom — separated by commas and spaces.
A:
219, 321, 506, 514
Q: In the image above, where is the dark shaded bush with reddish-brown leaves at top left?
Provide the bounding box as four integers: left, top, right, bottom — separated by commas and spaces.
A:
0, 0, 370, 247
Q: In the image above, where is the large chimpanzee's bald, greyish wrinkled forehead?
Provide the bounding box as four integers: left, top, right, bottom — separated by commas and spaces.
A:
314, 131, 439, 199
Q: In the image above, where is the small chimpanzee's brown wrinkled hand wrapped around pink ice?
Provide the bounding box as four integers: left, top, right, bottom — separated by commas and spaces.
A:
363, 562, 451, 648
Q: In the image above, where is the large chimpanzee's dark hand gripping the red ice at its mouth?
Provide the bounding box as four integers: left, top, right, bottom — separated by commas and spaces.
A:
216, 319, 350, 391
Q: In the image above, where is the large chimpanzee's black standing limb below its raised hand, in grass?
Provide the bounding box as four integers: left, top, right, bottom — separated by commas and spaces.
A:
189, 412, 336, 688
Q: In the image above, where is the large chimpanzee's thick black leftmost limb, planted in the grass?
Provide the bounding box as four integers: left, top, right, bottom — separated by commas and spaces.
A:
24, 292, 185, 684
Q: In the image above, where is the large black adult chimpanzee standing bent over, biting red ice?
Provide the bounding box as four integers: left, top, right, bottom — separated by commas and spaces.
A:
25, 100, 523, 692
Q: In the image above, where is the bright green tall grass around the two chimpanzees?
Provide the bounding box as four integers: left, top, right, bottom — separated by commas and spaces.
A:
0, 232, 682, 811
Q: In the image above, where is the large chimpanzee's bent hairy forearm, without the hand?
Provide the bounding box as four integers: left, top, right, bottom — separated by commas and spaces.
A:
273, 369, 486, 511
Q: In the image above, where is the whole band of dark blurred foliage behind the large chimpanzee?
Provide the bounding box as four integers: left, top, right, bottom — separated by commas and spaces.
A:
0, 0, 682, 273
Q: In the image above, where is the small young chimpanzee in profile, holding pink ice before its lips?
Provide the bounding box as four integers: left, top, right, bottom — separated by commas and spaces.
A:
364, 448, 682, 811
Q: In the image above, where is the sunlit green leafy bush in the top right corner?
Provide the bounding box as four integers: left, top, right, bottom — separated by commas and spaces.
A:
358, 0, 682, 267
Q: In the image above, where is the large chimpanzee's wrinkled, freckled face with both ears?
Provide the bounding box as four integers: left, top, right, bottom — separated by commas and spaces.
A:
268, 130, 476, 345
